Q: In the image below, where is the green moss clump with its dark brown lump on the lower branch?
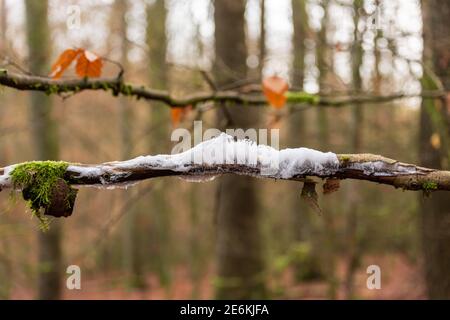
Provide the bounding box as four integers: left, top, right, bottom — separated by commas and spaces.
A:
11, 161, 78, 230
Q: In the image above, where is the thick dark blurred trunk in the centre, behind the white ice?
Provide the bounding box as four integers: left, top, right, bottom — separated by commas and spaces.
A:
214, 0, 266, 299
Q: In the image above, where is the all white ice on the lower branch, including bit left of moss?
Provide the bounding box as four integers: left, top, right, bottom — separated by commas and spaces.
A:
0, 133, 339, 188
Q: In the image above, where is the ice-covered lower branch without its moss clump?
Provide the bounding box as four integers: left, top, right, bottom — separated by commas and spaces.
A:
0, 134, 450, 192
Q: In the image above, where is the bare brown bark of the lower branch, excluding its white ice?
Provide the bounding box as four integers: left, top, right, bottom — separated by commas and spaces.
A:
0, 151, 450, 193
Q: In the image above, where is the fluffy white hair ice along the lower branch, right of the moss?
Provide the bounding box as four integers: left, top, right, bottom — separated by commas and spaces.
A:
69, 133, 339, 181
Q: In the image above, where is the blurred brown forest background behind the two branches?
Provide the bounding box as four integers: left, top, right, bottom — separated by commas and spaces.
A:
0, 0, 450, 299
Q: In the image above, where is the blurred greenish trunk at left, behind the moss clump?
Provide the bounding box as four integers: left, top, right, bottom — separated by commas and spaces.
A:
26, 0, 62, 299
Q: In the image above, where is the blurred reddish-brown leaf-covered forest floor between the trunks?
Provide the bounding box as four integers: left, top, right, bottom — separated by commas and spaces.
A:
12, 254, 426, 299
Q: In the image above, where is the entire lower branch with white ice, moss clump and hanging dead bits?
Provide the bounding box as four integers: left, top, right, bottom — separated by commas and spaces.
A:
0, 133, 450, 220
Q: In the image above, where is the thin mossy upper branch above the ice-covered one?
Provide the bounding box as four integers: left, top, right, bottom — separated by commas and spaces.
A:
0, 69, 447, 107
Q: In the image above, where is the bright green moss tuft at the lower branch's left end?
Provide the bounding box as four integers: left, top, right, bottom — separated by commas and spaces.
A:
11, 161, 69, 230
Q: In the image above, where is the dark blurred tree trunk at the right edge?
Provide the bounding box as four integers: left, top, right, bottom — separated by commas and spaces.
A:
419, 0, 450, 299
